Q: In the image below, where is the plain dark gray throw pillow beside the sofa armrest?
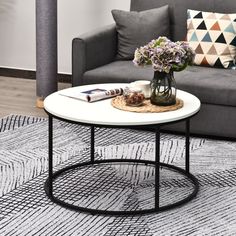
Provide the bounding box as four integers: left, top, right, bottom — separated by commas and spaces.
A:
112, 6, 169, 60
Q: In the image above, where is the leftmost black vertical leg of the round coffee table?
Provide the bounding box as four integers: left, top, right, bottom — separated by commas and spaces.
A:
48, 115, 53, 197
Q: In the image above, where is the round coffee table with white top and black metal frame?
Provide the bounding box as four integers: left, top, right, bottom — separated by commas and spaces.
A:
44, 84, 201, 215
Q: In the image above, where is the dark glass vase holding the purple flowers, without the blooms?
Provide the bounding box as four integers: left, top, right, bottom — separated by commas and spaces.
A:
150, 71, 176, 106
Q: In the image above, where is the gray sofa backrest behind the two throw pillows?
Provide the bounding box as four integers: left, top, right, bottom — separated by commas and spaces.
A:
130, 0, 236, 41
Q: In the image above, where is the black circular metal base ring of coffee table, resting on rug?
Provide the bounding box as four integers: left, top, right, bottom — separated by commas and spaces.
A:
44, 159, 199, 216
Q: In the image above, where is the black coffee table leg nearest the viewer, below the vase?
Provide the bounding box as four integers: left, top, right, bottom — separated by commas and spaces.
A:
155, 126, 160, 210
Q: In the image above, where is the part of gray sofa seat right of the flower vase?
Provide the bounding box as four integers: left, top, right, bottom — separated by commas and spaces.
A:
175, 66, 236, 106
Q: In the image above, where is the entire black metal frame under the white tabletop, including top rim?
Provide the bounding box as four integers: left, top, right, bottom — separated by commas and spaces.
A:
44, 110, 199, 215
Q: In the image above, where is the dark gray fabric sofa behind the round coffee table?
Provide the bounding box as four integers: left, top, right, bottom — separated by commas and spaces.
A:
72, 0, 236, 139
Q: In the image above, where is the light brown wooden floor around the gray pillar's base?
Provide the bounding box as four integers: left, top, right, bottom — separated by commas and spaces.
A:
0, 76, 71, 117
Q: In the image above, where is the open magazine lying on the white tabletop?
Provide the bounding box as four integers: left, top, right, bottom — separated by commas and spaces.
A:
59, 88, 123, 102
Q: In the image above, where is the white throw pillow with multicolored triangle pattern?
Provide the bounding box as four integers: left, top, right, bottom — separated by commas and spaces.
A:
187, 10, 236, 68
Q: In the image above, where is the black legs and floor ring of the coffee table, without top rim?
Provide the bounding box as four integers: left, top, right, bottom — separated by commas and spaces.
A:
44, 113, 199, 215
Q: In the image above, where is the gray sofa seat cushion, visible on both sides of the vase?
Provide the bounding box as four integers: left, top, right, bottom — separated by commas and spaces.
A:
83, 61, 236, 106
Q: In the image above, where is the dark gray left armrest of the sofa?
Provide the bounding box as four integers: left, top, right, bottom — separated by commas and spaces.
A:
72, 24, 117, 86
